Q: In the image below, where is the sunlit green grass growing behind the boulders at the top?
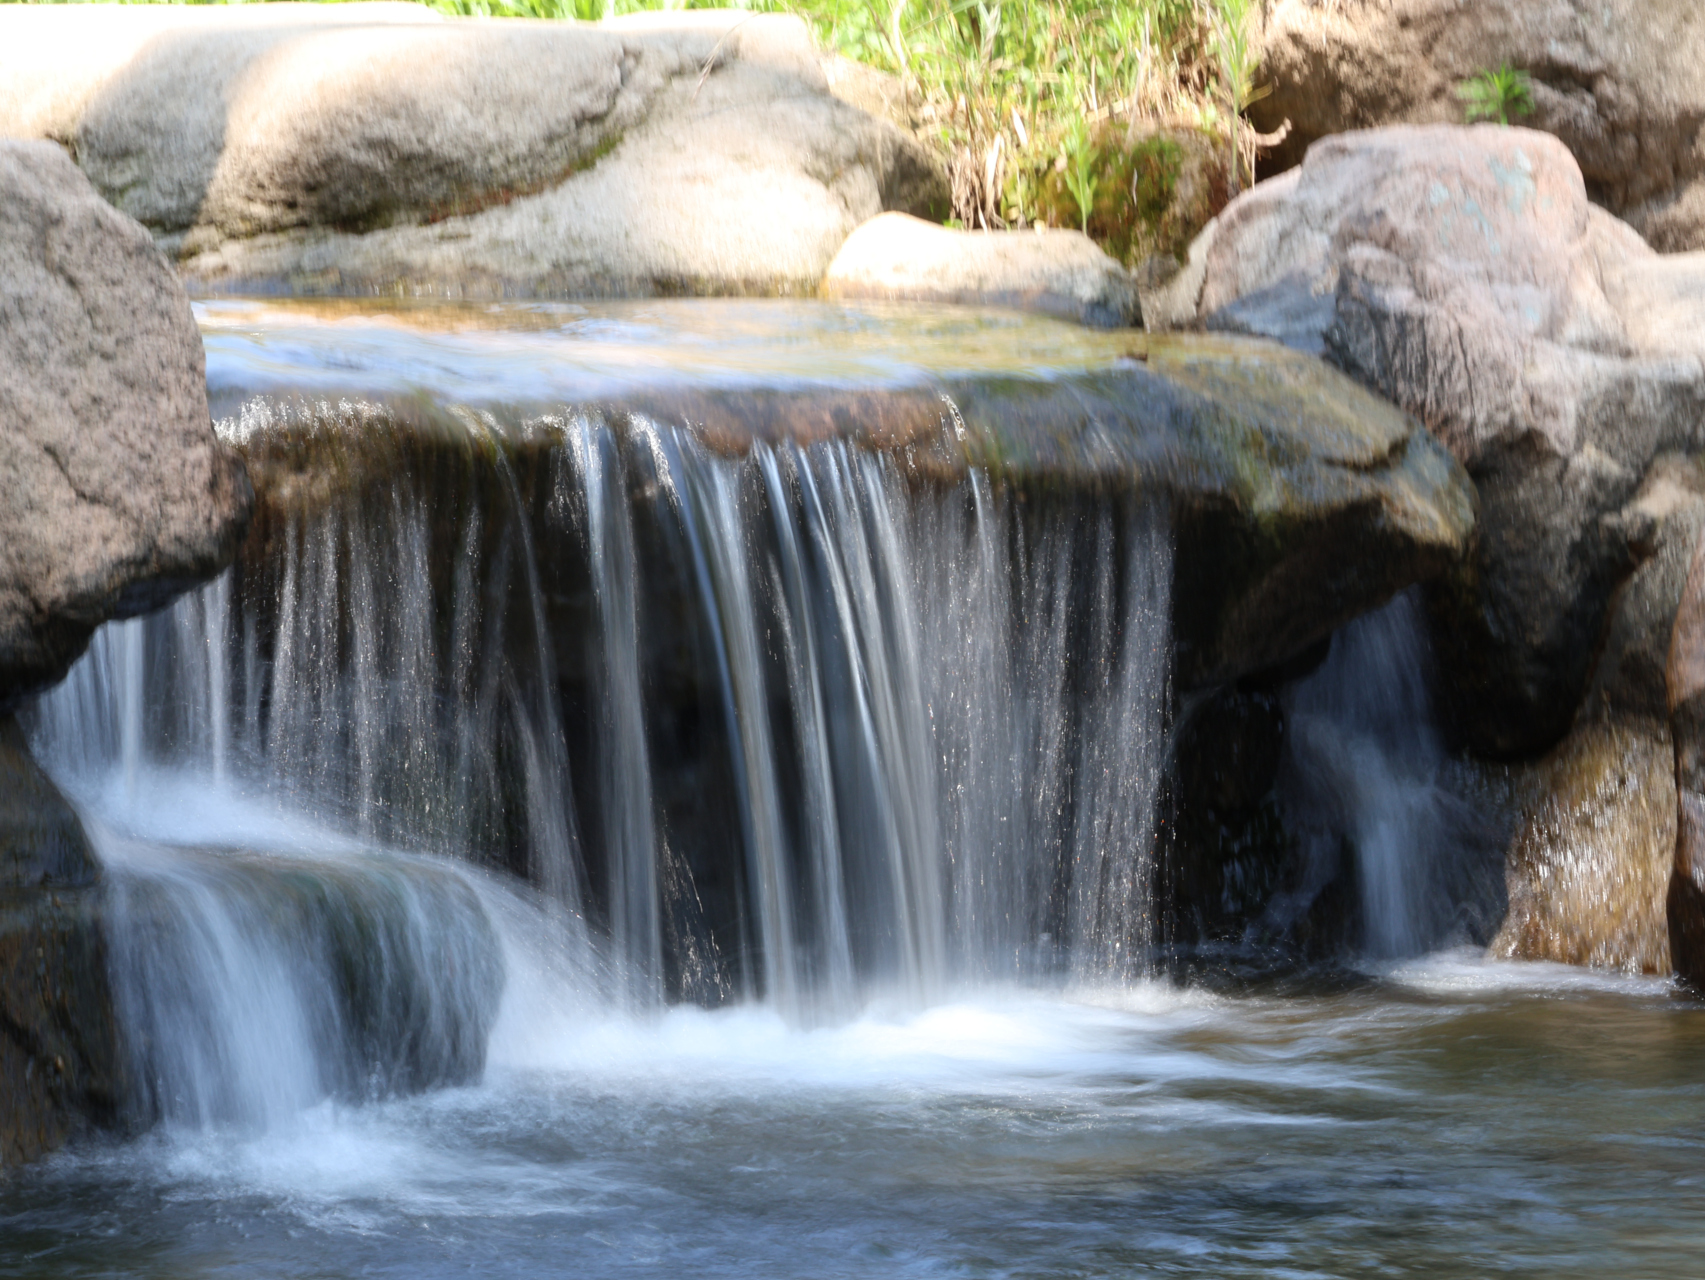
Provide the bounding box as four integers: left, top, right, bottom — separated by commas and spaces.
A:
6, 0, 1260, 255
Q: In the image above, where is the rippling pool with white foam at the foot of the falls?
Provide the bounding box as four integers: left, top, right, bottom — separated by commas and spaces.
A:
0, 934, 1705, 1277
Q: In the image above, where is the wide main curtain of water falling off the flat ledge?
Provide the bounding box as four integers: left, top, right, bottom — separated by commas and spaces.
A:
34, 406, 1171, 1049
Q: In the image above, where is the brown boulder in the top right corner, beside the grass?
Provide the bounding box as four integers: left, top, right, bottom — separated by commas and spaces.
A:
1251, 0, 1705, 252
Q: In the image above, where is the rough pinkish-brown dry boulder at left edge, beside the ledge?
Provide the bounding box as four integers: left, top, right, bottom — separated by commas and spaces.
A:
0, 141, 251, 711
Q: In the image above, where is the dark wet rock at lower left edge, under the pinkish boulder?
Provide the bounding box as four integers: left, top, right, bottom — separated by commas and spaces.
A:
0, 716, 123, 1168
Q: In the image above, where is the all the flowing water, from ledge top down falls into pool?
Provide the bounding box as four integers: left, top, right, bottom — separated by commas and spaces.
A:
0, 303, 1705, 1280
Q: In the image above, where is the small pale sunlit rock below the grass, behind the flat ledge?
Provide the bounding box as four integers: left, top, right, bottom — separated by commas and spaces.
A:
822, 213, 1139, 329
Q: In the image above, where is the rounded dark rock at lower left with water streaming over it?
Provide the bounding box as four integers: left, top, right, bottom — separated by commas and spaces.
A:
107, 849, 505, 1125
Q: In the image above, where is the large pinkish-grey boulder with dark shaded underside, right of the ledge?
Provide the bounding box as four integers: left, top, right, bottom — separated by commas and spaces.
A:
1151, 126, 1705, 757
